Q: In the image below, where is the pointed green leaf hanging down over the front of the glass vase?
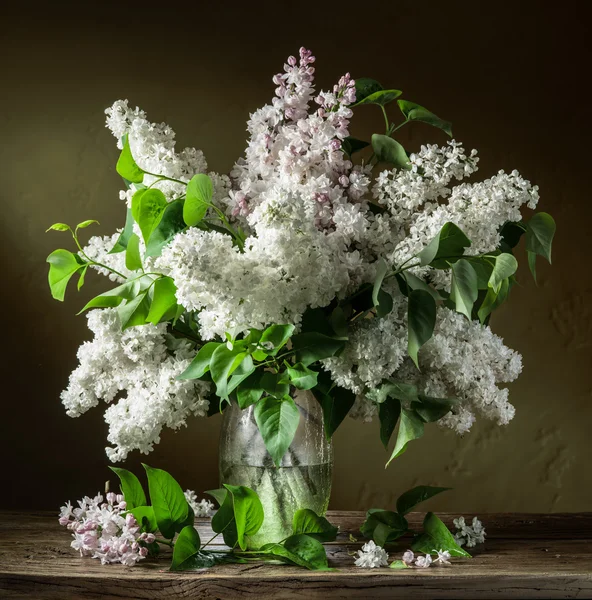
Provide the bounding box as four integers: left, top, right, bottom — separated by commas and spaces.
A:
255, 396, 300, 467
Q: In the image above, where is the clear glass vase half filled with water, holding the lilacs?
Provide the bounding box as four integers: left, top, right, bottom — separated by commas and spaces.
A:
220, 390, 333, 548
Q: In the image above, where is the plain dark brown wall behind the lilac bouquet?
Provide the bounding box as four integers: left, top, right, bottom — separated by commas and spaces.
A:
0, 1, 592, 513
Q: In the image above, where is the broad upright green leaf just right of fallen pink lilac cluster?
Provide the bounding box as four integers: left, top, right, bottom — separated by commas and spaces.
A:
143, 465, 193, 539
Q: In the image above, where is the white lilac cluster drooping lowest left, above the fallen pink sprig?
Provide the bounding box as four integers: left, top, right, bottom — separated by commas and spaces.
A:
61, 309, 209, 461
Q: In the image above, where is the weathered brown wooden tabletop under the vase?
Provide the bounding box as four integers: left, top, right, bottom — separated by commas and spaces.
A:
0, 512, 592, 600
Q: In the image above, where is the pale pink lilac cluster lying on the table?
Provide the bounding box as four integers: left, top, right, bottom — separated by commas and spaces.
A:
59, 492, 155, 567
